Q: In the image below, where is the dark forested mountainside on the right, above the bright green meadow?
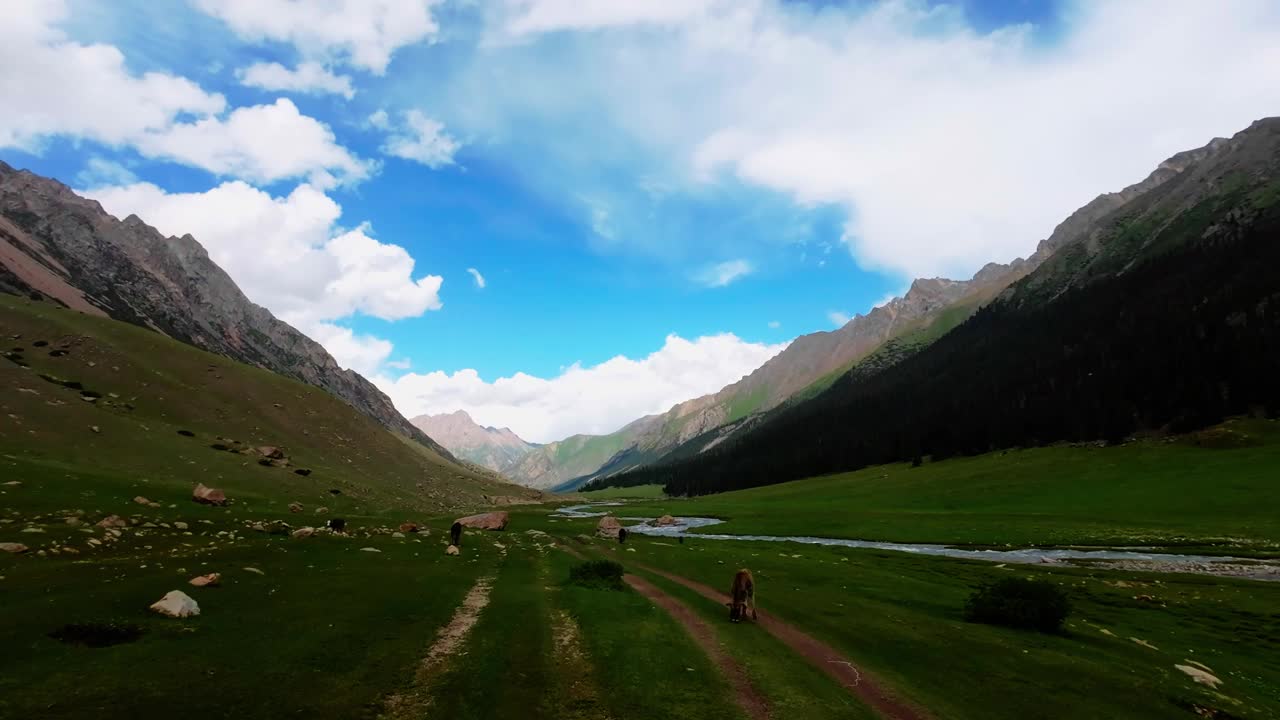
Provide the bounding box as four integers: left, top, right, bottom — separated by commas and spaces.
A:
606, 119, 1280, 495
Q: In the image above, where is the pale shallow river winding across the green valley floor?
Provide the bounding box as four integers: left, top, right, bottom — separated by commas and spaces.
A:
553, 502, 1280, 580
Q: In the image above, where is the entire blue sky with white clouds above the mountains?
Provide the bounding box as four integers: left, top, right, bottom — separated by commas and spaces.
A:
0, 0, 1280, 442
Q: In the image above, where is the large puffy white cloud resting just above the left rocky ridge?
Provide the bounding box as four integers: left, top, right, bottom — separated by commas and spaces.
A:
79, 181, 443, 373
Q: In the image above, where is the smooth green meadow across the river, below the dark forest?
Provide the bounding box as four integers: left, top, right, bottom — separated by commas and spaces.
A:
616, 420, 1280, 543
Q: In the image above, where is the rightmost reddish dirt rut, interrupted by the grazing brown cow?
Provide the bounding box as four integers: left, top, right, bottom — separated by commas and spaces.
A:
639, 565, 928, 720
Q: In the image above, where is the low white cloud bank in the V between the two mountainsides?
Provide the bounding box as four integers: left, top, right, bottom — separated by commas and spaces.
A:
375, 334, 786, 442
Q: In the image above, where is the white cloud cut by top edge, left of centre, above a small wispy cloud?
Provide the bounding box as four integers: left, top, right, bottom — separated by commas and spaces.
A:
196, 0, 440, 74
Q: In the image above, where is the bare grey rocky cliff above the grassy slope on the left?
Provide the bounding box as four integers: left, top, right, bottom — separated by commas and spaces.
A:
0, 163, 449, 457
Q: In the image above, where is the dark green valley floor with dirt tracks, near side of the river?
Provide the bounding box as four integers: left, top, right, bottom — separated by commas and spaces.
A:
0, 482, 1280, 720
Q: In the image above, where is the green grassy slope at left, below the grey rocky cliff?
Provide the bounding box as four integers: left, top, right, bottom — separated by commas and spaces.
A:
0, 288, 534, 514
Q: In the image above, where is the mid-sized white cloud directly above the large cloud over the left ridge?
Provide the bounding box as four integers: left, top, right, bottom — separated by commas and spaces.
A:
138, 97, 371, 186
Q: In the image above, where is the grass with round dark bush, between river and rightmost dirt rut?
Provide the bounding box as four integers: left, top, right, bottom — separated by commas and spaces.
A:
586, 527, 1280, 720
